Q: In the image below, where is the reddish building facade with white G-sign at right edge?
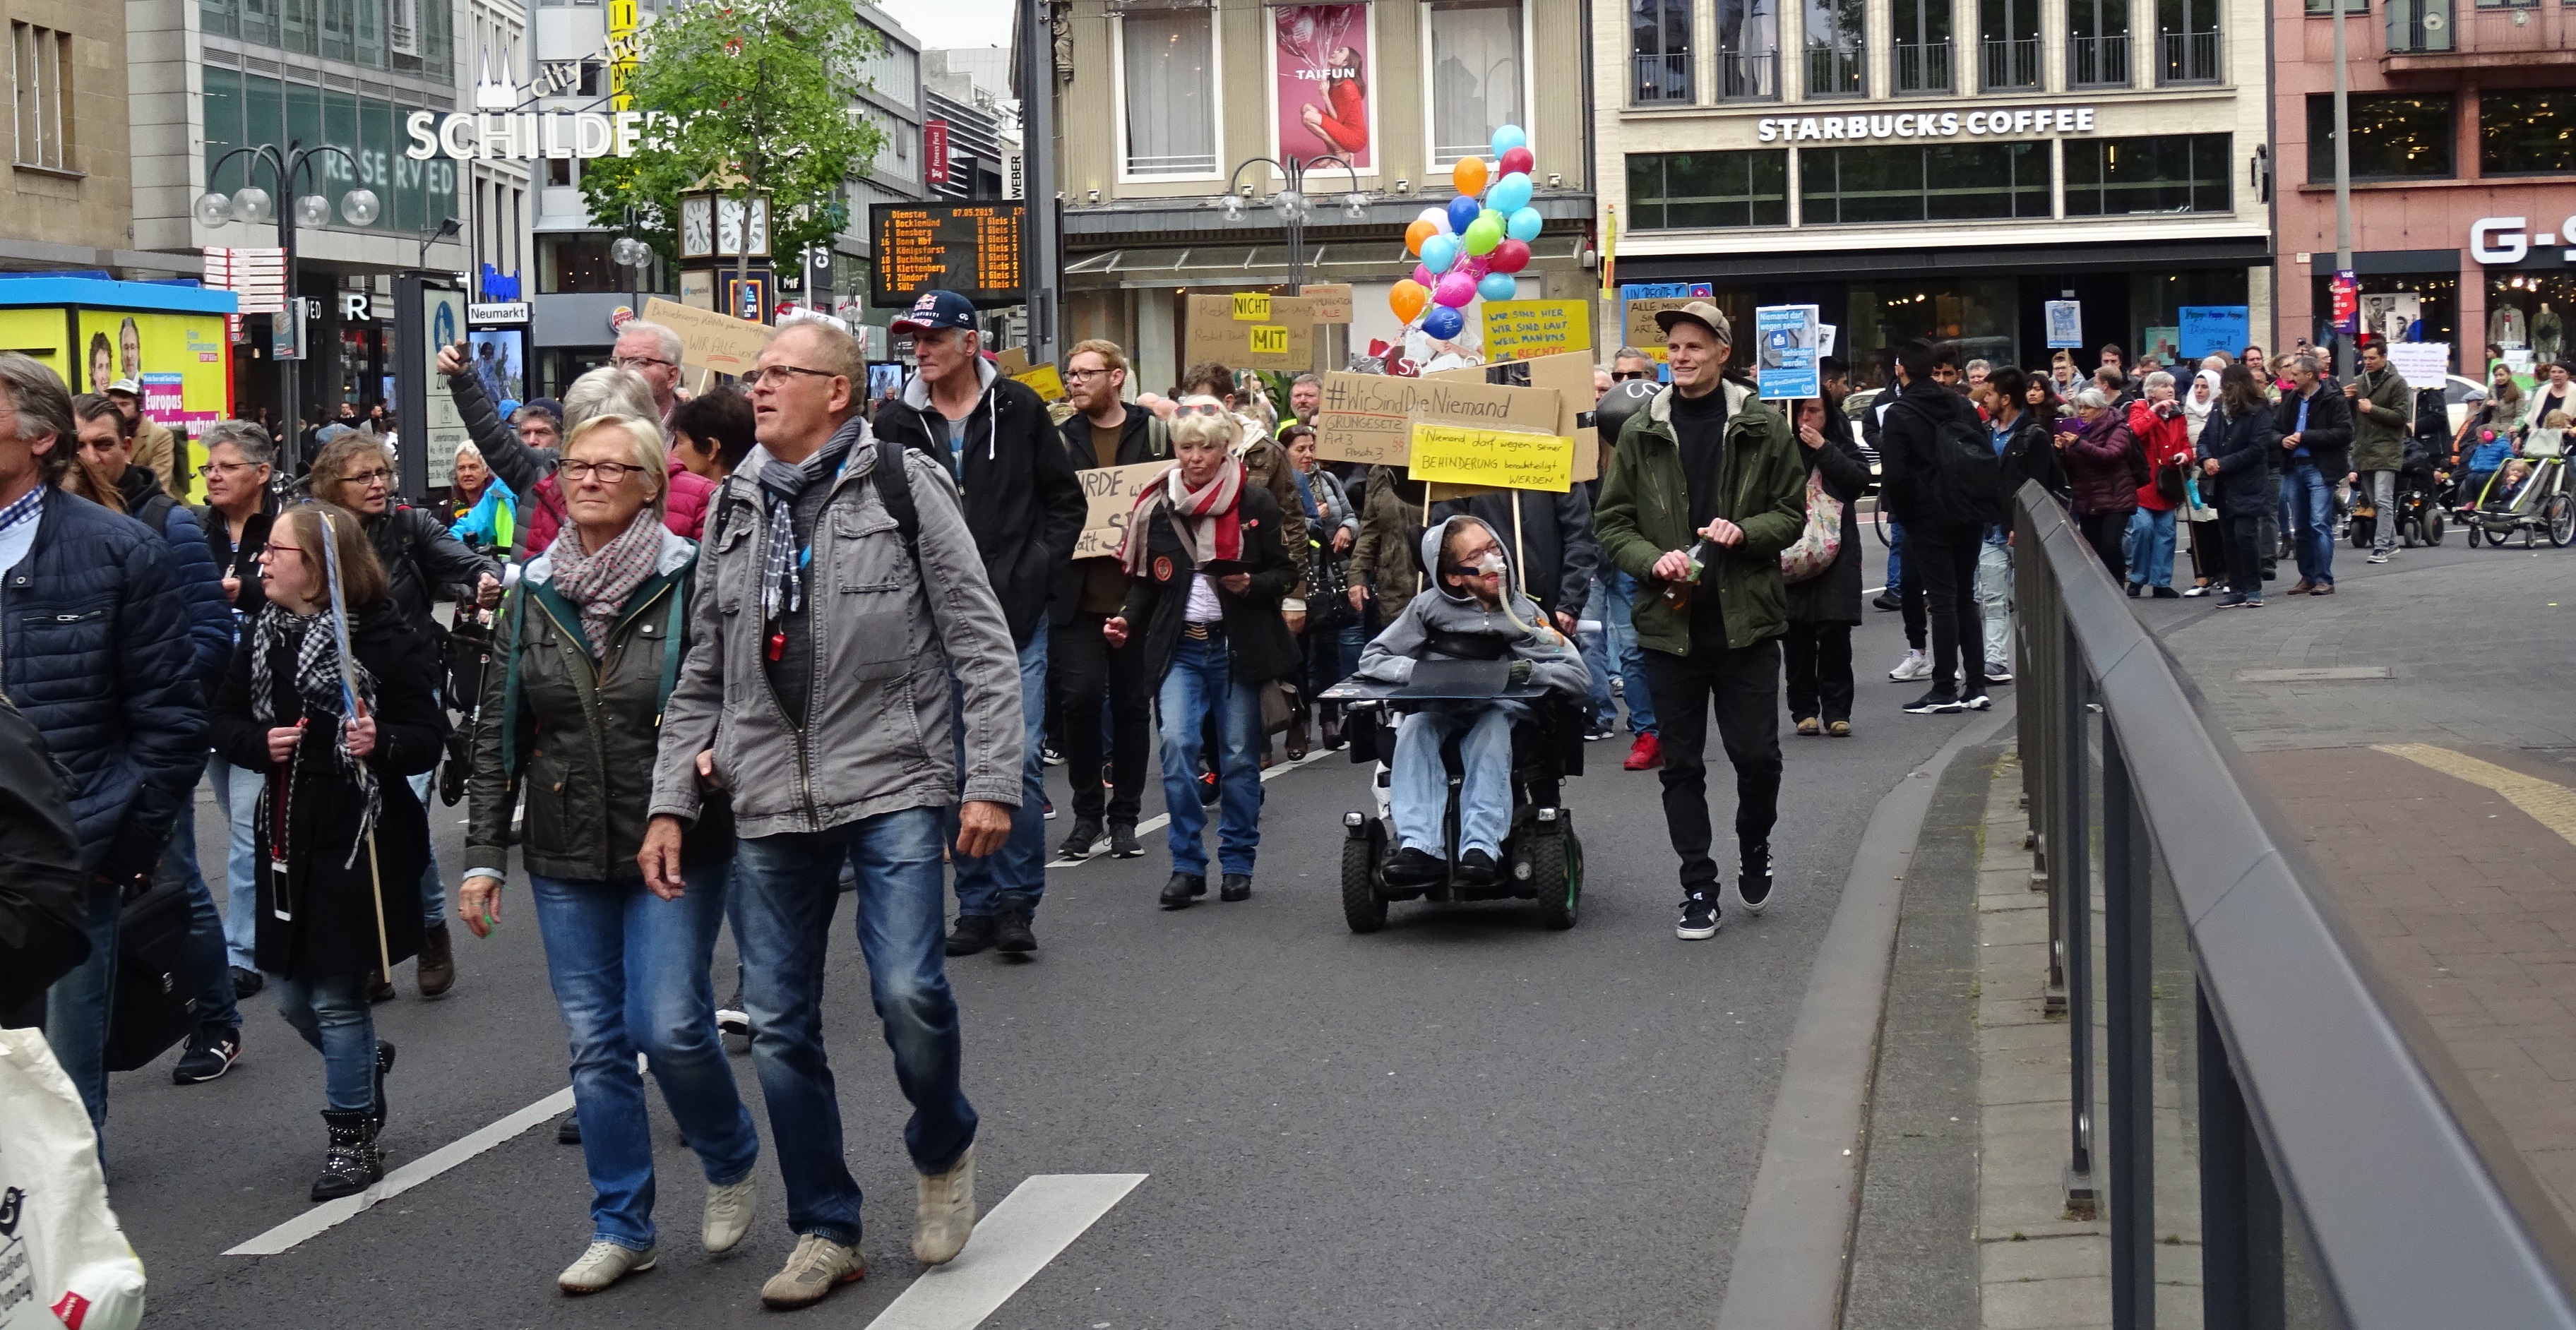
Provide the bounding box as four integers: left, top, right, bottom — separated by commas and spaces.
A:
2272, 0, 2576, 379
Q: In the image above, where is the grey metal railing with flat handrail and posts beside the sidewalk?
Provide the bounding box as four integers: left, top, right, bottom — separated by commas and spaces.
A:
2015, 484, 2576, 1330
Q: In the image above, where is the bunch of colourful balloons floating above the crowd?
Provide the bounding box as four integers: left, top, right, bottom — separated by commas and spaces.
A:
1386, 124, 1546, 340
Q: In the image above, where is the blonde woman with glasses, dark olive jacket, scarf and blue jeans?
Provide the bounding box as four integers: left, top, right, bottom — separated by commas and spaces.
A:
456, 415, 760, 1294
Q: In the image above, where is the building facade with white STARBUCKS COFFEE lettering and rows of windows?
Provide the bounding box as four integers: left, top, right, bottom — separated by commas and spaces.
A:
1592, 0, 2272, 379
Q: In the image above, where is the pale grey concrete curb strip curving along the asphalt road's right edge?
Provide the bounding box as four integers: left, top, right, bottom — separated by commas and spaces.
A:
1718, 698, 2015, 1330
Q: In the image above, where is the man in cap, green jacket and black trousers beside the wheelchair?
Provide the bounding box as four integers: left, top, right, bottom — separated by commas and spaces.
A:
1599, 301, 1806, 941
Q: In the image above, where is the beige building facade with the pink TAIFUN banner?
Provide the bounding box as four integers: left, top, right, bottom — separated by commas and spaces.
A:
1033, 0, 1599, 392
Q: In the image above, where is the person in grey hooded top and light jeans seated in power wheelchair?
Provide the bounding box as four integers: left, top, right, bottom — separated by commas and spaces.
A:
1360, 515, 1592, 887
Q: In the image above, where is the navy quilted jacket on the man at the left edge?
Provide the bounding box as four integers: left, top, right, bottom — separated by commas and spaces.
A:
0, 490, 206, 879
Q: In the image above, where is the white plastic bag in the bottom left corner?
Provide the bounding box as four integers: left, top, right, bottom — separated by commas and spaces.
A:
0, 1031, 144, 1330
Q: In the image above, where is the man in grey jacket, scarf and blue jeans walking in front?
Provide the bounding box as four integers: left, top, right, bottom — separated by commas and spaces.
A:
636, 322, 1020, 1307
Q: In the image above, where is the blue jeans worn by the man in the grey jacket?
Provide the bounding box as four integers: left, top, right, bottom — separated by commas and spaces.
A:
727, 807, 977, 1245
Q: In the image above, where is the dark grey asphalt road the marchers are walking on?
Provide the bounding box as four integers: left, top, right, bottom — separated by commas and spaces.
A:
90, 536, 1957, 1330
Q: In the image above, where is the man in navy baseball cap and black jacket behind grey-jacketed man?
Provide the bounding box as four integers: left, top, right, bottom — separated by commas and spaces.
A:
876, 292, 1090, 957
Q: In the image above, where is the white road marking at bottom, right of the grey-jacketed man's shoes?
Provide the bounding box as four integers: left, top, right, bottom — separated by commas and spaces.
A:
868, 1175, 1149, 1330
